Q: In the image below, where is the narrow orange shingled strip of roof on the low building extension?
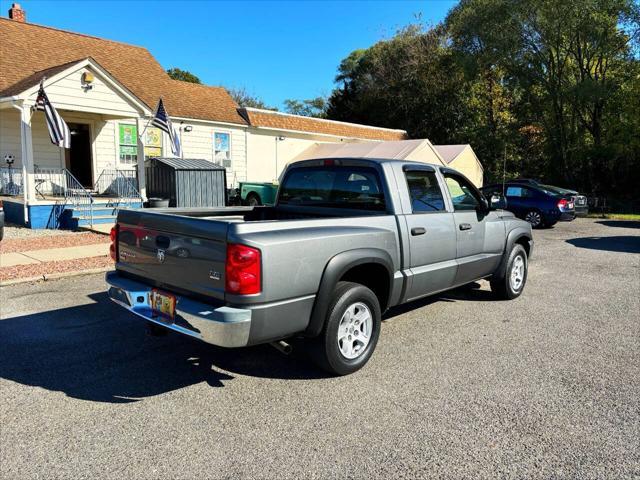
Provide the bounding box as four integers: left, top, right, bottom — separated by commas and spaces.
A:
240, 108, 407, 140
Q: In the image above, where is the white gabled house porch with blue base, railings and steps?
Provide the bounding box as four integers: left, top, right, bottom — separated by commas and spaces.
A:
0, 58, 151, 228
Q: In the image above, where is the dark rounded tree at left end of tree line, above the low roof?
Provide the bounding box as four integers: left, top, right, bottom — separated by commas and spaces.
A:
327, 25, 467, 143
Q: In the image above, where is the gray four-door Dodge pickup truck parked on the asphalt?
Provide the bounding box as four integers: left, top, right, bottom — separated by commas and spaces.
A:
106, 158, 533, 375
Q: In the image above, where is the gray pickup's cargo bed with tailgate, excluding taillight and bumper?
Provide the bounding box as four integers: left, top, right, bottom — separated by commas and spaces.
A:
116, 206, 399, 303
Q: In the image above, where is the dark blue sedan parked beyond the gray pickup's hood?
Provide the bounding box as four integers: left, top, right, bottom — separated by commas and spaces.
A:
481, 182, 576, 228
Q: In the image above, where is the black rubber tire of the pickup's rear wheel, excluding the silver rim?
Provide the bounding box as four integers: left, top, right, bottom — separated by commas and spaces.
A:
311, 282, 382, 375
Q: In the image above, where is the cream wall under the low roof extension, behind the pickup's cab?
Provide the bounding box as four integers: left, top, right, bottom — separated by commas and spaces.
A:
247, 128, 344, 182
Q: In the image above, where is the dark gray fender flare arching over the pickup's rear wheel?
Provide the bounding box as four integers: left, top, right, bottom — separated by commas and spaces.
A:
304, 248, 393, 337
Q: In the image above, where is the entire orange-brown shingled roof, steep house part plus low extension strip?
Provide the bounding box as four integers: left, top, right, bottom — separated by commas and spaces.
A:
0, 18, 407, 140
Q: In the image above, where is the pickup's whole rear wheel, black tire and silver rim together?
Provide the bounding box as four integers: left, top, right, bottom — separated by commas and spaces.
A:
312, 282, 382, 375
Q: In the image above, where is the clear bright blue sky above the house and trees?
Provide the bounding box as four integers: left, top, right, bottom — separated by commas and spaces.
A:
0, 0, 457, 108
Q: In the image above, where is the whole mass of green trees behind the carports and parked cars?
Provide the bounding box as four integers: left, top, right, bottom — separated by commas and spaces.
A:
326, 0, 640, 197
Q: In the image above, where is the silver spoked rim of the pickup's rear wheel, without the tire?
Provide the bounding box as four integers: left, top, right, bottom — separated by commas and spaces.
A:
337, 302, 373, 360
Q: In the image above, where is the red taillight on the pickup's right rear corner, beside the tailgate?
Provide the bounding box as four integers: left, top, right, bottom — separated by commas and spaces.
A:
225, 244, 262, 295
